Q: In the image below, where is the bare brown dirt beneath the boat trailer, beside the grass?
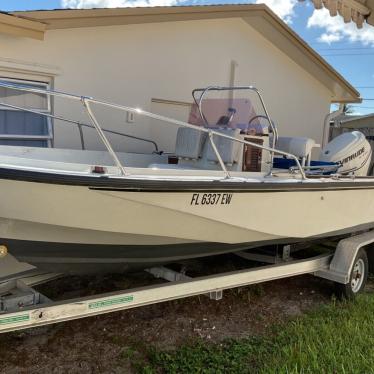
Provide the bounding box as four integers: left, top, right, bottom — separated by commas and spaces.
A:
0, 258, 333, 374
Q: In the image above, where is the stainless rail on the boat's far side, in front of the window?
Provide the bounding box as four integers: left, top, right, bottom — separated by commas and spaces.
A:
0, 101, 160, 153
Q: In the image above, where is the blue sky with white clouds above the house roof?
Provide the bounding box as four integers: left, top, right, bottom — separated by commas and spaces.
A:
0, 0, 374, 114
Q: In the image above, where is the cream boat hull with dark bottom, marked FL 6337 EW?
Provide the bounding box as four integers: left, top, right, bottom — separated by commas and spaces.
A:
0, 173, 374, 271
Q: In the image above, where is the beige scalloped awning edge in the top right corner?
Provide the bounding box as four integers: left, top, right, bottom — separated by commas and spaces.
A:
299, 0, 374, 29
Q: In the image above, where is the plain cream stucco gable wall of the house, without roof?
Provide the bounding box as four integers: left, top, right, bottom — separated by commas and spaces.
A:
0, 19, 331, 150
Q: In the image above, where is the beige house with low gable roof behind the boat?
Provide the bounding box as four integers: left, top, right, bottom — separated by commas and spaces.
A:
0, 5, 360, 152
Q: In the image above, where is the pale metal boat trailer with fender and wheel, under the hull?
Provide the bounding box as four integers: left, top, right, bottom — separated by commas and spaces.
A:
0, 230, 374, 332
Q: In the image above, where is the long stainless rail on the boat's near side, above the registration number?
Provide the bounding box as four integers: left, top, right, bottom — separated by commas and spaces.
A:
0, 81, 307, 179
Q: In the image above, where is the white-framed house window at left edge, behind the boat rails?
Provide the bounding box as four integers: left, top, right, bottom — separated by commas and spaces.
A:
0, 77, 53, 147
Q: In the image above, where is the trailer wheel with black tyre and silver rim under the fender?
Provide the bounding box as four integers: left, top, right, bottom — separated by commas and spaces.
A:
335, 248, 369, 299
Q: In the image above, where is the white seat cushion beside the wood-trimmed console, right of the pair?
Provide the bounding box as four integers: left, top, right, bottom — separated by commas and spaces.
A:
206, 128, 242, 164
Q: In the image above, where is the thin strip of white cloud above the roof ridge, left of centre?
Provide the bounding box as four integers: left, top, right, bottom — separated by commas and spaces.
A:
61, 0, 178, 9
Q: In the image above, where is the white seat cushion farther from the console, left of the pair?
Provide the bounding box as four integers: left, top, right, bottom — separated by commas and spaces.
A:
175, 127, 206, 160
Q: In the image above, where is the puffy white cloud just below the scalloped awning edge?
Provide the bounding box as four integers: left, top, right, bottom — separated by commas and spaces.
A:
307, 9, 374, 46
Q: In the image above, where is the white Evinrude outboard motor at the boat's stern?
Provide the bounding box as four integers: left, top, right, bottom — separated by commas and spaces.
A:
320, 131, 372, 176
